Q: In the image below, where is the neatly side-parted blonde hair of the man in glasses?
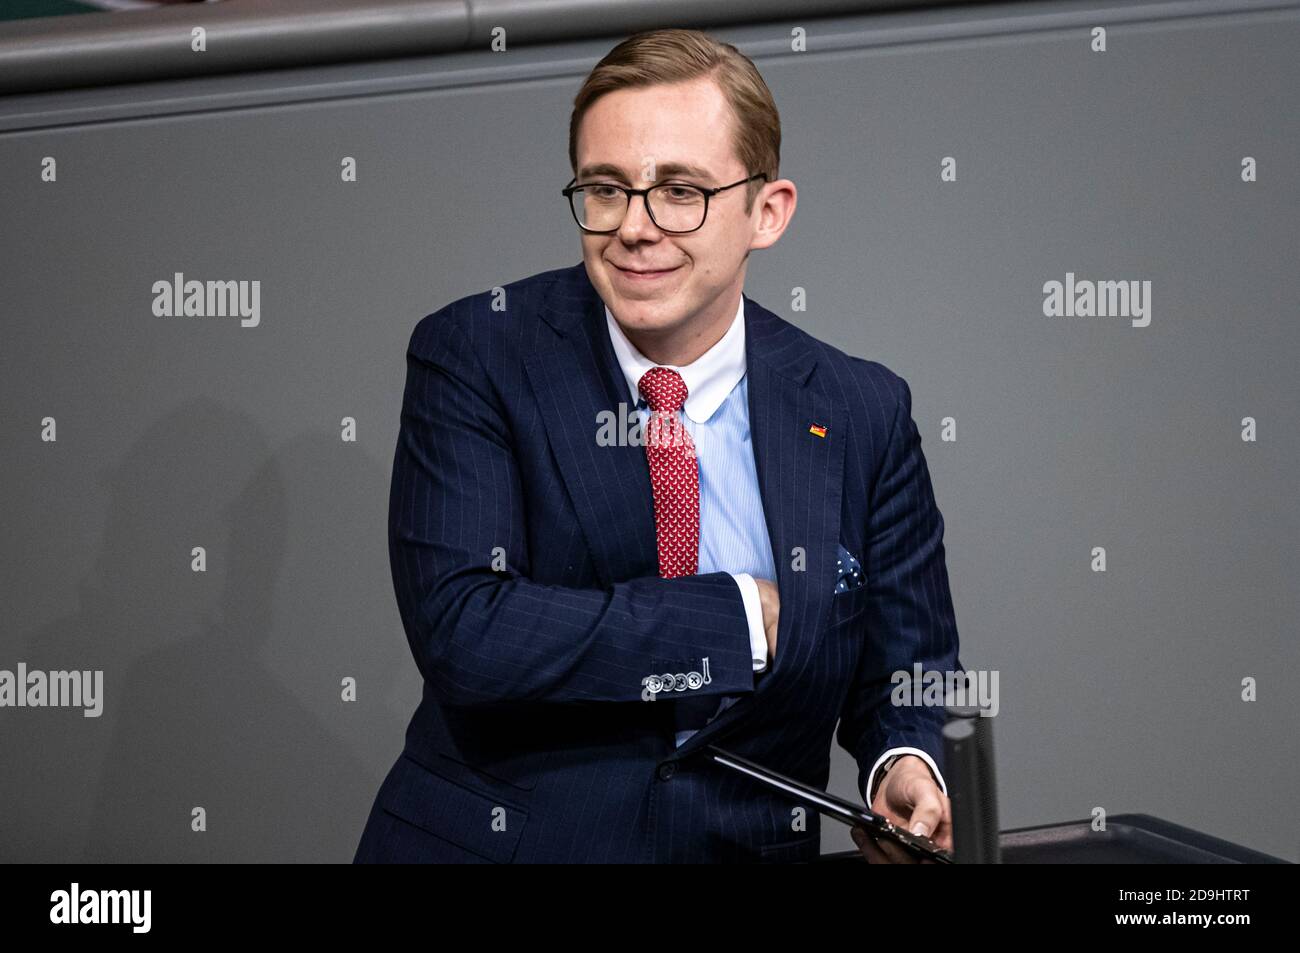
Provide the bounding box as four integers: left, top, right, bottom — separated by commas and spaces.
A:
569, 30, 781, 215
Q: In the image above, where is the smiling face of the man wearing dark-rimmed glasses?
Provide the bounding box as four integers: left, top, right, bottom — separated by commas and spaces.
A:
577, 79, 776, 339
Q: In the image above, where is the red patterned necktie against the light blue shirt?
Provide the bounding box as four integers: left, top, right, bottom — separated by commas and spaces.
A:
637, 367, 699, 579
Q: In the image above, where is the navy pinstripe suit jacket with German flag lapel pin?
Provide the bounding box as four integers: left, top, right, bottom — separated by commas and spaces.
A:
355, 264, 959, 862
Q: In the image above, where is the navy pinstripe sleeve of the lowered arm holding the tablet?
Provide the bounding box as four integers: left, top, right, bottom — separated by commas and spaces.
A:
837, 373, 961, 790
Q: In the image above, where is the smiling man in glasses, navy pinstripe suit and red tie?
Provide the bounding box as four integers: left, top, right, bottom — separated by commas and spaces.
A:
356, 30, 959, 862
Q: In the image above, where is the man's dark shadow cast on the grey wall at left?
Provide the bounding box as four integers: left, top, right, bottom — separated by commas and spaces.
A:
0, 399, 408, 862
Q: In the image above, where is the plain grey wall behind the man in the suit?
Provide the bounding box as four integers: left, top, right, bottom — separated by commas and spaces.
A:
0, 3, 1300, 861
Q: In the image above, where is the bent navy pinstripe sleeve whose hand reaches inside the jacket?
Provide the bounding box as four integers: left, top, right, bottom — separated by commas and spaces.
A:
389, 309, 754, 706
